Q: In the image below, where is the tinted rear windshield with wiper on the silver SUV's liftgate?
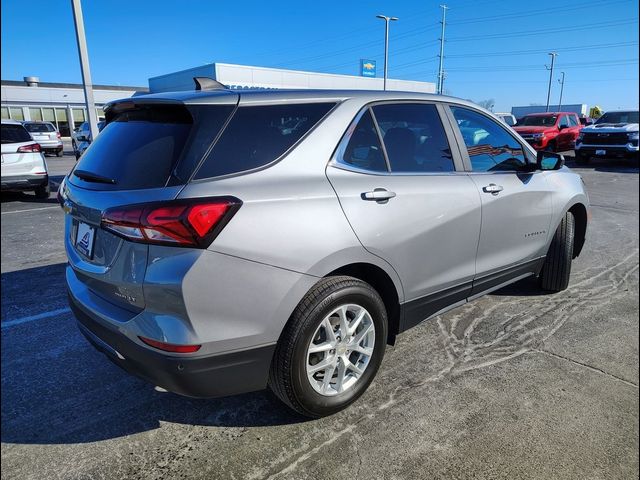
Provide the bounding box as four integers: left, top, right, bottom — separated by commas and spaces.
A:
72, 105, 193, 190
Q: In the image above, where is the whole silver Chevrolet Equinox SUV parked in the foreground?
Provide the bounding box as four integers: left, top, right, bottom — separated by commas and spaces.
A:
59, 85, 588, 417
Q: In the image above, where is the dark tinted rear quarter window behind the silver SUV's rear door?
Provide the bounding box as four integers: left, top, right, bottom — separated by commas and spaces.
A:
195, 103, 335, 179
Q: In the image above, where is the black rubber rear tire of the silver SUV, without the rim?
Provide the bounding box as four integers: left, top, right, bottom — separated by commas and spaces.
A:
269, 276, 387, 418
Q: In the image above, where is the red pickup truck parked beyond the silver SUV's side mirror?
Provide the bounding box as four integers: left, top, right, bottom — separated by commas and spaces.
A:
513, 112, 583, 152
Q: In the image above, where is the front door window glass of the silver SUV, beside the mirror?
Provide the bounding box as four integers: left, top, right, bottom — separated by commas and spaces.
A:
451, 107, 528, 172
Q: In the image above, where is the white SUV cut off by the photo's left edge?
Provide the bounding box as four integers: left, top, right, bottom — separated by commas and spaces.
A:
1, 120, 49, 198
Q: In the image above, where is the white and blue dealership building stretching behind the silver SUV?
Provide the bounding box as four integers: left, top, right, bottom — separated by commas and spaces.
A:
1, 62, 436, 137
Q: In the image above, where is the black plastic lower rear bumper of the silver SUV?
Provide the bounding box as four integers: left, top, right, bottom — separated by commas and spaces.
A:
68, 292, 275, 398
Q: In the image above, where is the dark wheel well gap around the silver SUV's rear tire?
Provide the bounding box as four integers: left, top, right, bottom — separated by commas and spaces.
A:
327, 263, 400, 345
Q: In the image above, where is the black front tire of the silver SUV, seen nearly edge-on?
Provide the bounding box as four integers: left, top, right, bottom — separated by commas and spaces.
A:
540, 212, 575, 292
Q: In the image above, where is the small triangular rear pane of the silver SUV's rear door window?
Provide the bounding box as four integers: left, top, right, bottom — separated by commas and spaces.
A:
338, 109, 387, 172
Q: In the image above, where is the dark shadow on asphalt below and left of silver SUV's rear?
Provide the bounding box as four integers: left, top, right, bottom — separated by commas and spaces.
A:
0, 263, 308, 444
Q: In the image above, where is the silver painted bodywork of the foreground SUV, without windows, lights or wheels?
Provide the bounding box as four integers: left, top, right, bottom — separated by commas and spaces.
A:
62, 90, 588, 398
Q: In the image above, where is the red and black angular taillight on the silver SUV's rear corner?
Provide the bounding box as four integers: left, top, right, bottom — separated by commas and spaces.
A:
102, 197, 242, 248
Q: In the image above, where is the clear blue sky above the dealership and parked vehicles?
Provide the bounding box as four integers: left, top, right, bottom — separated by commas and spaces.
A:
2, 0, 638, 111
